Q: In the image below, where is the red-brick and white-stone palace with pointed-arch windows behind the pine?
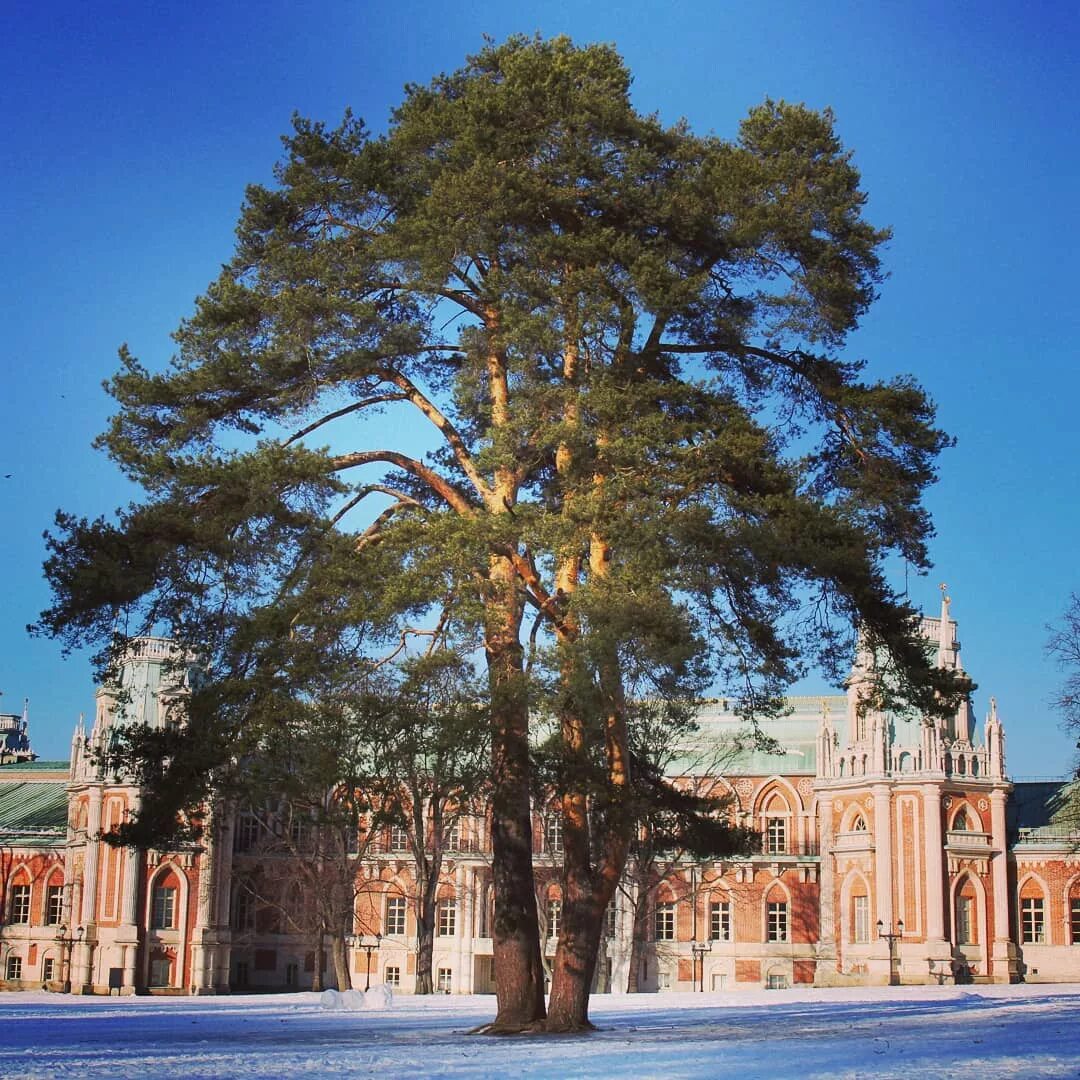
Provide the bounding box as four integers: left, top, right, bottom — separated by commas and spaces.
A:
0, 598, 1080, 994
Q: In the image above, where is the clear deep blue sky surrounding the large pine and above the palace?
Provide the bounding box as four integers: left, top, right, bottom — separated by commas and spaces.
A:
0, 0, 1080, 775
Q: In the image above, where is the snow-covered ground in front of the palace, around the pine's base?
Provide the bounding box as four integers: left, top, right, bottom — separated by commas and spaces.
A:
0, 984, 1080, 1080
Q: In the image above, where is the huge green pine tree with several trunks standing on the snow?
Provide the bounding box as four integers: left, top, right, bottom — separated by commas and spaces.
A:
40, 37, 963, 1028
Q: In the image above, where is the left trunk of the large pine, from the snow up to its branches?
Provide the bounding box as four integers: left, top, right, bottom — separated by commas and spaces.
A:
484, 558, 544, 1034
